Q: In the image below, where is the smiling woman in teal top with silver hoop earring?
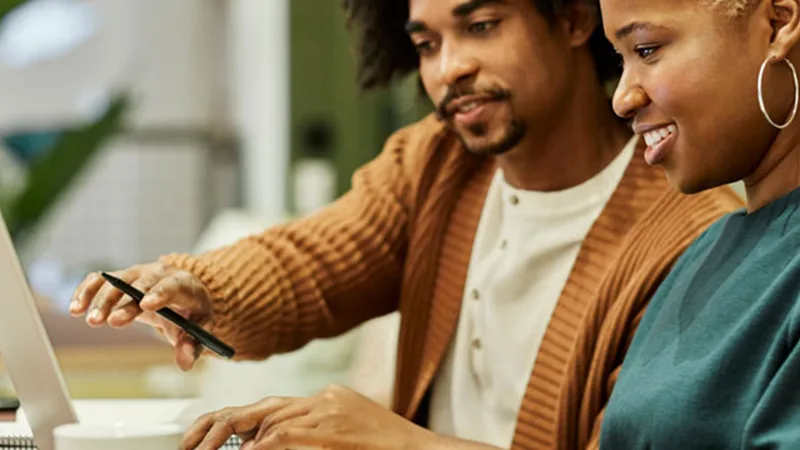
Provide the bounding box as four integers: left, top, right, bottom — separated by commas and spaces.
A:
601, 0, 800, 450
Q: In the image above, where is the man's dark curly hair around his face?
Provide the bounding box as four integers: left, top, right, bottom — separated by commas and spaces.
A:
342, 0, 620, 89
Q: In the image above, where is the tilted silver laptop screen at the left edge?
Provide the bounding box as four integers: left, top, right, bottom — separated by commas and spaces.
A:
0, 214, 78, 450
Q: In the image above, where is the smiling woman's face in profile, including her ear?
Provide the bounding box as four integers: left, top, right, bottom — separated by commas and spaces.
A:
601, 0, 793, 193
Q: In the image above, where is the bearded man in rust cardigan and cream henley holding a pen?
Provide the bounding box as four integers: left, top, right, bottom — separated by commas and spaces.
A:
72, 0, 740, 449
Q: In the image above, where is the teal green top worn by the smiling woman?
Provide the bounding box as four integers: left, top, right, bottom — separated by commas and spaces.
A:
600, 190, 800, 450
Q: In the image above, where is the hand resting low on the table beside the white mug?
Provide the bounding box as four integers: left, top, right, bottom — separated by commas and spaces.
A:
181, 386, 441, 450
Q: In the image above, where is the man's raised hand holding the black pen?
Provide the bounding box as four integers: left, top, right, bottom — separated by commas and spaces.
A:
69, 263, 213, 370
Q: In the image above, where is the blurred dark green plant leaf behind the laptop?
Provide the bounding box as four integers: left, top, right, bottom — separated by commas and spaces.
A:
0, 0, 129, 241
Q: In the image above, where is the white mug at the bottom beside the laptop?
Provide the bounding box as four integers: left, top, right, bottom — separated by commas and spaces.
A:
53, 423, 183, 450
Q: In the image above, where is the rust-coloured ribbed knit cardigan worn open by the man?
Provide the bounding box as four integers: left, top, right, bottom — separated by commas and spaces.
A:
162, 117, 742, 449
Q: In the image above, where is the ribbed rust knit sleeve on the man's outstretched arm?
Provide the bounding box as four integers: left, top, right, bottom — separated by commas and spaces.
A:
161, 124, 424, 359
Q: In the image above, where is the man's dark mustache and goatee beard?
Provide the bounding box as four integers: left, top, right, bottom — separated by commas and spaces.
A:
436, 85, 528, 155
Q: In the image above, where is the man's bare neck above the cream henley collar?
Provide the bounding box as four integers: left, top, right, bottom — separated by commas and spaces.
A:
497, 83, 631, 192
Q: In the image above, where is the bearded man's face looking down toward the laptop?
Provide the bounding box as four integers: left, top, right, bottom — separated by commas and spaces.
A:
406, 0, 571, 154
